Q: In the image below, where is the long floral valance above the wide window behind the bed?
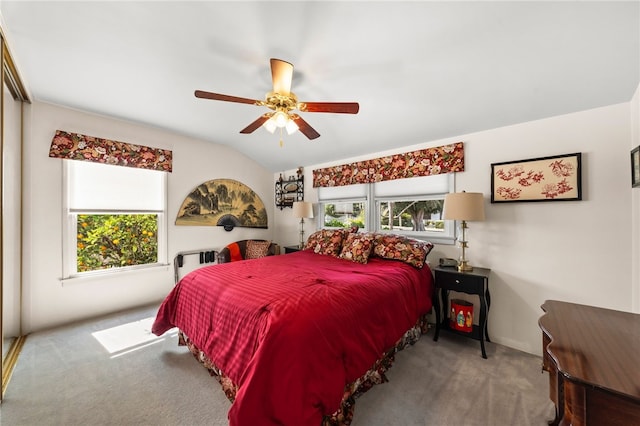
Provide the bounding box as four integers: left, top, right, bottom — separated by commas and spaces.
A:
313, 142, 464, 188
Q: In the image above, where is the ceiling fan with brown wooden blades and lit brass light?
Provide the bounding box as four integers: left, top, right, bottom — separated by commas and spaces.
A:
195, 58, 360, 139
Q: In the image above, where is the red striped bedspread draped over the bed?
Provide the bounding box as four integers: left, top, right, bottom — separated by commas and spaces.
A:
153, 251, 433, 426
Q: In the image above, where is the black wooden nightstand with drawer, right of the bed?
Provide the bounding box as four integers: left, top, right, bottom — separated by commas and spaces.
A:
433, 266, 491, 359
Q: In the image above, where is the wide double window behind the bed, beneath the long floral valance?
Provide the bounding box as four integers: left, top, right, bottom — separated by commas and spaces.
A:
318, 173, 455, 244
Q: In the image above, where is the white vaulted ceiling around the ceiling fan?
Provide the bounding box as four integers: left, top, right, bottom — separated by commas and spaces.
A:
0, 0, 640, 172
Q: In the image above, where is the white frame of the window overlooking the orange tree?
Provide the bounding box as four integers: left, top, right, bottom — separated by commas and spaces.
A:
62, 160, 168, 280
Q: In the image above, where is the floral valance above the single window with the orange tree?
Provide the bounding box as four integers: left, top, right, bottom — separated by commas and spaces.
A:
49, 130, 173, 172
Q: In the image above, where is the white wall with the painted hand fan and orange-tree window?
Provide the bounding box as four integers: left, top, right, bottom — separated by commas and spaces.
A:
23, 102, 273, 333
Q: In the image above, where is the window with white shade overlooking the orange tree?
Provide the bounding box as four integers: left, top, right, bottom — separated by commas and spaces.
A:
64, 160, 166, 277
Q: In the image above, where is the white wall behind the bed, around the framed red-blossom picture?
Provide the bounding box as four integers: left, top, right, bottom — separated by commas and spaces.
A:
275, 101, 640, 354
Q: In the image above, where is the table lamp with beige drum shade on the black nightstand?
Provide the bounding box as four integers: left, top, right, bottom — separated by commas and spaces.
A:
443, 191, 484, 272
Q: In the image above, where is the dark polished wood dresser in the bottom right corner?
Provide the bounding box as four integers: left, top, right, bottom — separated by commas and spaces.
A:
538, 300, 640, 426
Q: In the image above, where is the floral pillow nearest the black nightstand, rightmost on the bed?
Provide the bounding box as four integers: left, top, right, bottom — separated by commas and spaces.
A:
373, 234, 433, 268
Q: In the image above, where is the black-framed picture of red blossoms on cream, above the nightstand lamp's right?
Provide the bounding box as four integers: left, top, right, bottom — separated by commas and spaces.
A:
491, 152, 582, 203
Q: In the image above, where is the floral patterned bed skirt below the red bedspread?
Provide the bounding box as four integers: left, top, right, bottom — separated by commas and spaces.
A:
178, 315, 429, 426
